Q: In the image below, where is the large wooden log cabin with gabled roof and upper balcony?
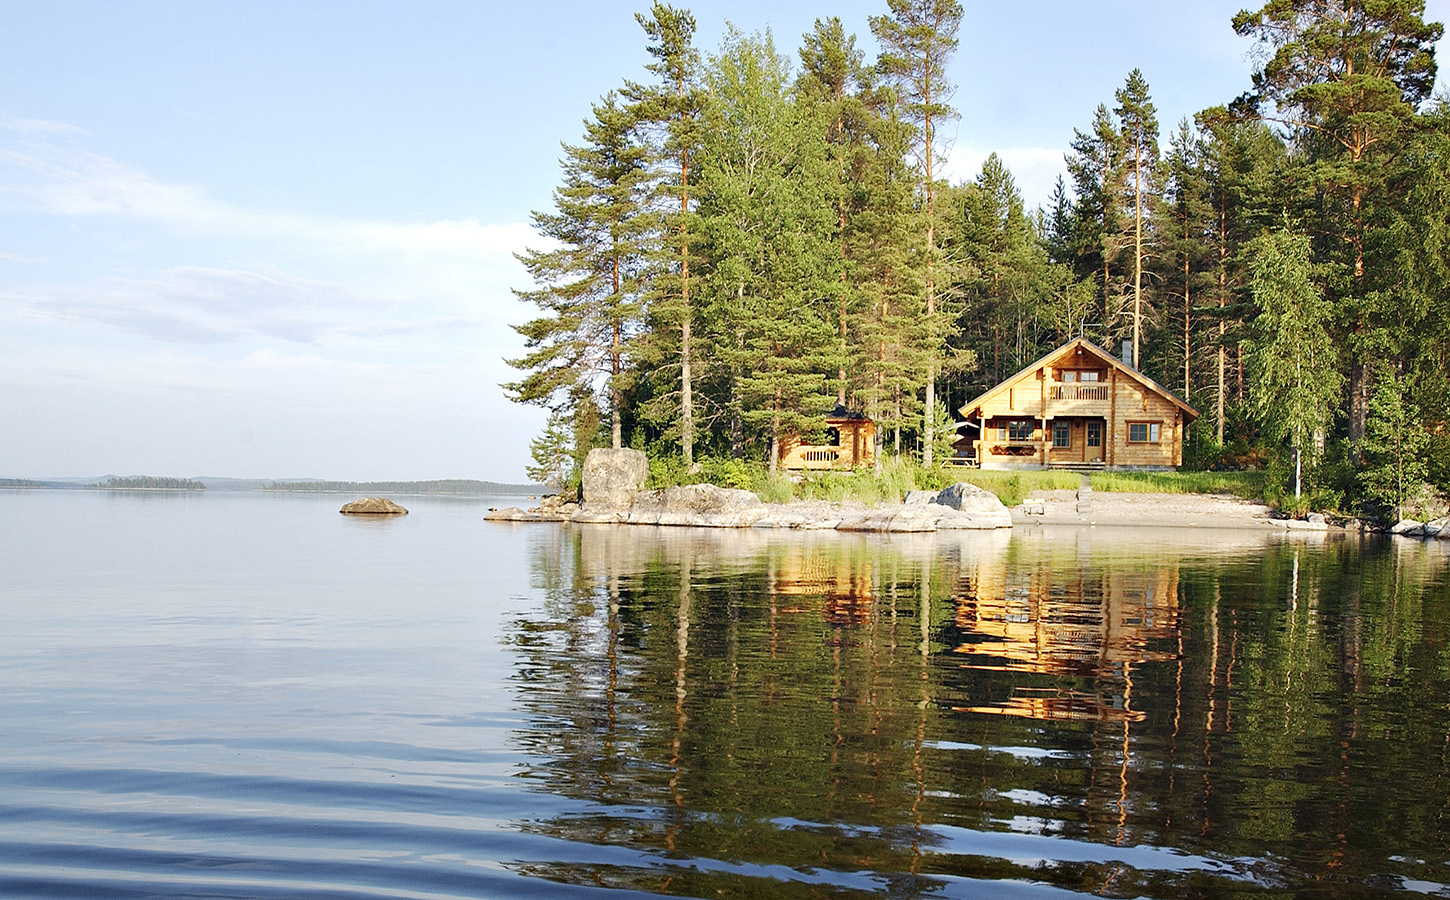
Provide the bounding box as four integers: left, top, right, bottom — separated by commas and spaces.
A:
961, 338, 1198, 470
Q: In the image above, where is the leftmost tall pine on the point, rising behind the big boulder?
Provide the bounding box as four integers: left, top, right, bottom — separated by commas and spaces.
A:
505, 93, 651, 448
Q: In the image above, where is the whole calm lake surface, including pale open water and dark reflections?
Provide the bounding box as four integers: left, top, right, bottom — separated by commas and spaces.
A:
0, 491, 1450, 900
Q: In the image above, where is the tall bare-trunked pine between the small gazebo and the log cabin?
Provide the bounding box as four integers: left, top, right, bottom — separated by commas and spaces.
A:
870, 0, 963, 467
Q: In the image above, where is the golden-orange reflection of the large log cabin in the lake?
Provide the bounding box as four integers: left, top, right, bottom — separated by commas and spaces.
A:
954, 553, 1179, 722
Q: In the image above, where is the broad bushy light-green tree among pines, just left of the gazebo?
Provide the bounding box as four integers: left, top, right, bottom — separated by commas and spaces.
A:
699, 29, 837, 468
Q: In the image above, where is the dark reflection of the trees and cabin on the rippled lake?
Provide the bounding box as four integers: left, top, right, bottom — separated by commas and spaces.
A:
512, 528, 1450, 896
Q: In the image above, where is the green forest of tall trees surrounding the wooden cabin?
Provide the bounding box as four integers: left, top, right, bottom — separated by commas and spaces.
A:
505, 0, 1450, 507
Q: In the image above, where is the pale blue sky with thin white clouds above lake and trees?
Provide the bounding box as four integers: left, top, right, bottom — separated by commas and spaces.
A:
0, 0, 1450, 481
